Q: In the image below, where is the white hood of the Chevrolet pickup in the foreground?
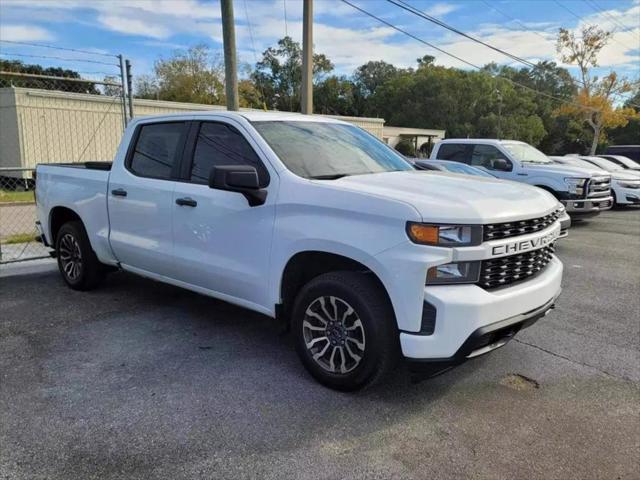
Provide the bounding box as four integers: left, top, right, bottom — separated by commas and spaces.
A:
331, 171, 559, 224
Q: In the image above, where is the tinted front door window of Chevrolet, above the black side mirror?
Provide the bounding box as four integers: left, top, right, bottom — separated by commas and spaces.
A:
190, 122, 269, 187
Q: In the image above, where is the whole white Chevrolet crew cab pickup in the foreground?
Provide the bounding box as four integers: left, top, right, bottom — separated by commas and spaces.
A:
36, 112, 562, 390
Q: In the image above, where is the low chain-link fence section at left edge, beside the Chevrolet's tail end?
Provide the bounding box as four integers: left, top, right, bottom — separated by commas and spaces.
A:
0, 168, 49, 263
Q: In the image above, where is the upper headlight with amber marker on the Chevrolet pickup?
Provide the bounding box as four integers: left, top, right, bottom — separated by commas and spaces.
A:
407, 222, 482, 247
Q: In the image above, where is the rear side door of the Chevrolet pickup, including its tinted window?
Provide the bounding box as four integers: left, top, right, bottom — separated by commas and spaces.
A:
108, 121, 188, 276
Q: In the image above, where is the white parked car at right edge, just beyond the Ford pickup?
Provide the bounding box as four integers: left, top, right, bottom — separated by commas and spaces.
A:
551, 155, 640, 206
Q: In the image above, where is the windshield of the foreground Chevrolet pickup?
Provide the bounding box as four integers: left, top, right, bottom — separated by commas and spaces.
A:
253, 121, 414, 180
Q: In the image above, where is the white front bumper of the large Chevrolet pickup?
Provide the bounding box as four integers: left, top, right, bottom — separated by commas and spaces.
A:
400, 257, 562, 363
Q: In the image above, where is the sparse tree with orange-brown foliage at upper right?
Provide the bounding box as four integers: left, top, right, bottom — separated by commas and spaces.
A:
556, 26, 637, 155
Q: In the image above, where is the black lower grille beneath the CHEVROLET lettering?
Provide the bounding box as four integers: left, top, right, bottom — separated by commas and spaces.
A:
478, 244, 554, 289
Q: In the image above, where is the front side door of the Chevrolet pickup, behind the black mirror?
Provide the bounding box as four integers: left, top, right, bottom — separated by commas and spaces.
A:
172, 118, 278, 307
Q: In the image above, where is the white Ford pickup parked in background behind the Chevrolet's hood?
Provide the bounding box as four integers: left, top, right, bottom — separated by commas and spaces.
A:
431, 138, 613, 218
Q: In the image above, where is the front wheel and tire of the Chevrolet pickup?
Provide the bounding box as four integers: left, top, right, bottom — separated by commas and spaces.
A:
292, 272, 400, 391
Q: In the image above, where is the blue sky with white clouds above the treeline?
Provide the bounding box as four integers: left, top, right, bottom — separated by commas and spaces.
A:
0, 0, 640, 88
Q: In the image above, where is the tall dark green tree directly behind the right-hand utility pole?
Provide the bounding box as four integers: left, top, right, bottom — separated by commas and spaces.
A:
251, 37, 333, 112
